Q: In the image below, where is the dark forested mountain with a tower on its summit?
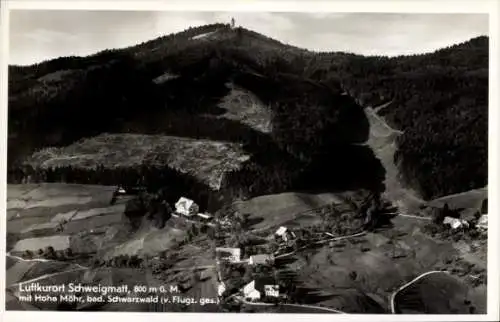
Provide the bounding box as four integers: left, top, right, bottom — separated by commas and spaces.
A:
8, 24, 488, 199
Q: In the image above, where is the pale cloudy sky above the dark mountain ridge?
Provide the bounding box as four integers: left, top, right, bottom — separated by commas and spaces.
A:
9, 10, 488, 65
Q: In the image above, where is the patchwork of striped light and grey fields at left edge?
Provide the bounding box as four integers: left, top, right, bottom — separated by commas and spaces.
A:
7, 183, 125, 252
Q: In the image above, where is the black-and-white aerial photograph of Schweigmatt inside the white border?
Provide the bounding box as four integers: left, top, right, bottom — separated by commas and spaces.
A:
2, 10, 489, 314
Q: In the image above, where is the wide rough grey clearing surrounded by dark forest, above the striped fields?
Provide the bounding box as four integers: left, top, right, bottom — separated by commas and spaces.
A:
29, 134, 250, 189
